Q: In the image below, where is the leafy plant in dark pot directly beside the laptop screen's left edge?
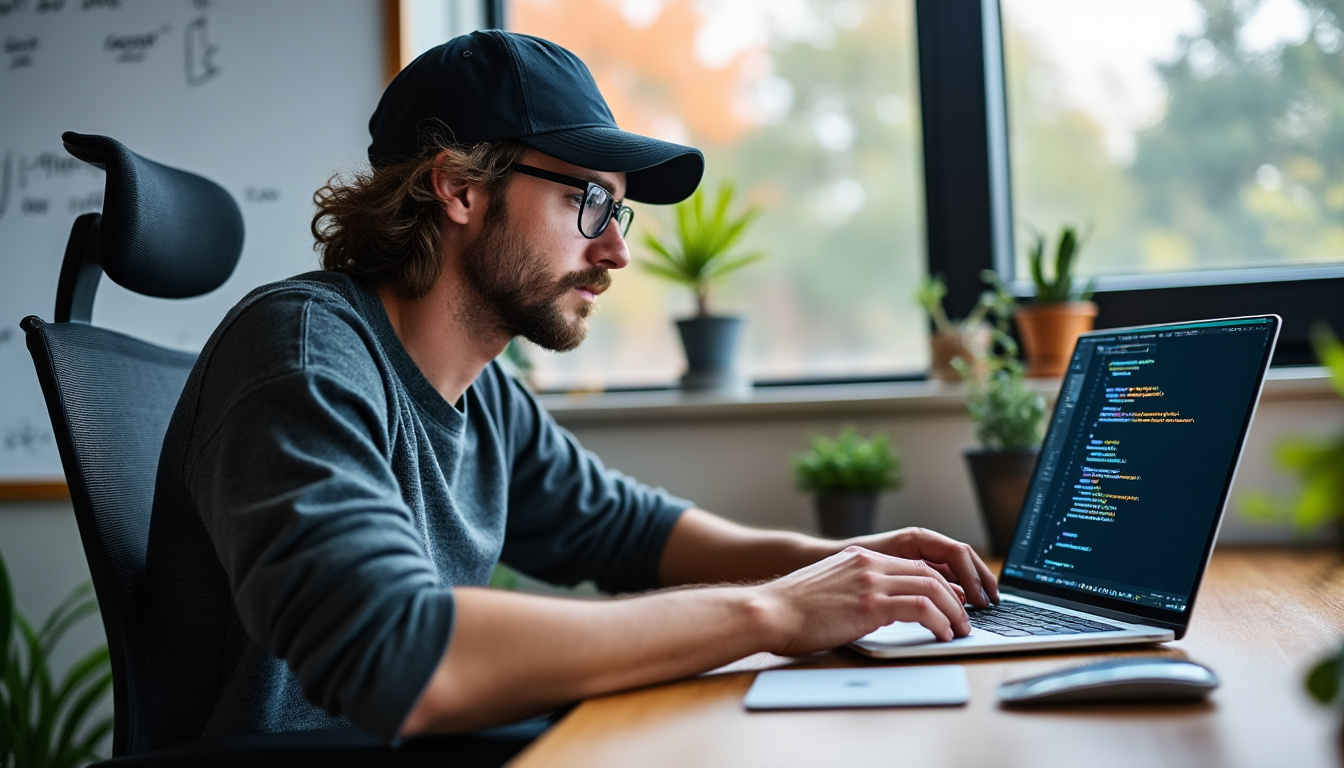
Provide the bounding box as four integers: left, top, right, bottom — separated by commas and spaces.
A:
953, 279, 1046, 555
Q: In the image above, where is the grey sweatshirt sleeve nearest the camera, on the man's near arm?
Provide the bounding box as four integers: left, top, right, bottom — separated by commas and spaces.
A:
185, 370, 453, 740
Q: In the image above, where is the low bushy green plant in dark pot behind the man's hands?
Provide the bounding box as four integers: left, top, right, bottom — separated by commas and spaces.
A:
793, 426, 905, 539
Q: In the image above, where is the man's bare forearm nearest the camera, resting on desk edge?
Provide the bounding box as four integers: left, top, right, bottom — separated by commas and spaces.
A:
402, 586, 778, 734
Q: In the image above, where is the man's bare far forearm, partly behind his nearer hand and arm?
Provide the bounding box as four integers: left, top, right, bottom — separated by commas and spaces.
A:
659, 510, 845, 586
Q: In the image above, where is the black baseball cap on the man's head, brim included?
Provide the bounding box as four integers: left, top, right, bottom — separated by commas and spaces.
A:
368, 30, 704, 203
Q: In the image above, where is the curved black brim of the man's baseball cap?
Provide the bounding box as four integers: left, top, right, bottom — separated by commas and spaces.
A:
519, 125, 704, 204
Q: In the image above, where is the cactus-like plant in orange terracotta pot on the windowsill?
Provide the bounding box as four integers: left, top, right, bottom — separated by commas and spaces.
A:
1016, 225, 1097, 377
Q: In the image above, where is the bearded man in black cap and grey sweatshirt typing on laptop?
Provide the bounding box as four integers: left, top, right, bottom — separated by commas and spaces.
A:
148, 31, 997, 742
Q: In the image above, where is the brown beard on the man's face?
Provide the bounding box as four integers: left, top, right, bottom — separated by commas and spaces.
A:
461, 201, 612, 352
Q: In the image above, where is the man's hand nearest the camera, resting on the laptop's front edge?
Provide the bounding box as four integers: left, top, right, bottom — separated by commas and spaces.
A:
757, 546, 970, 656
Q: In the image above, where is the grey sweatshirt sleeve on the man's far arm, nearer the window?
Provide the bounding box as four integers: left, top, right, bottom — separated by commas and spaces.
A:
496, 371, 694, 593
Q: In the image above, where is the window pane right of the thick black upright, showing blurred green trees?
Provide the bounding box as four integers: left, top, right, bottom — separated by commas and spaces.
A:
1001, 0, 1344, 286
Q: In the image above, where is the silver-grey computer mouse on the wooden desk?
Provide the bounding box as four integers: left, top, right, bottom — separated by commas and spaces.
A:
999, 656, 1218, 705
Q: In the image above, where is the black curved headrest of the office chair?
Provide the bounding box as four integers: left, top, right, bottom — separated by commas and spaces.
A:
60, 132, 243, 299
